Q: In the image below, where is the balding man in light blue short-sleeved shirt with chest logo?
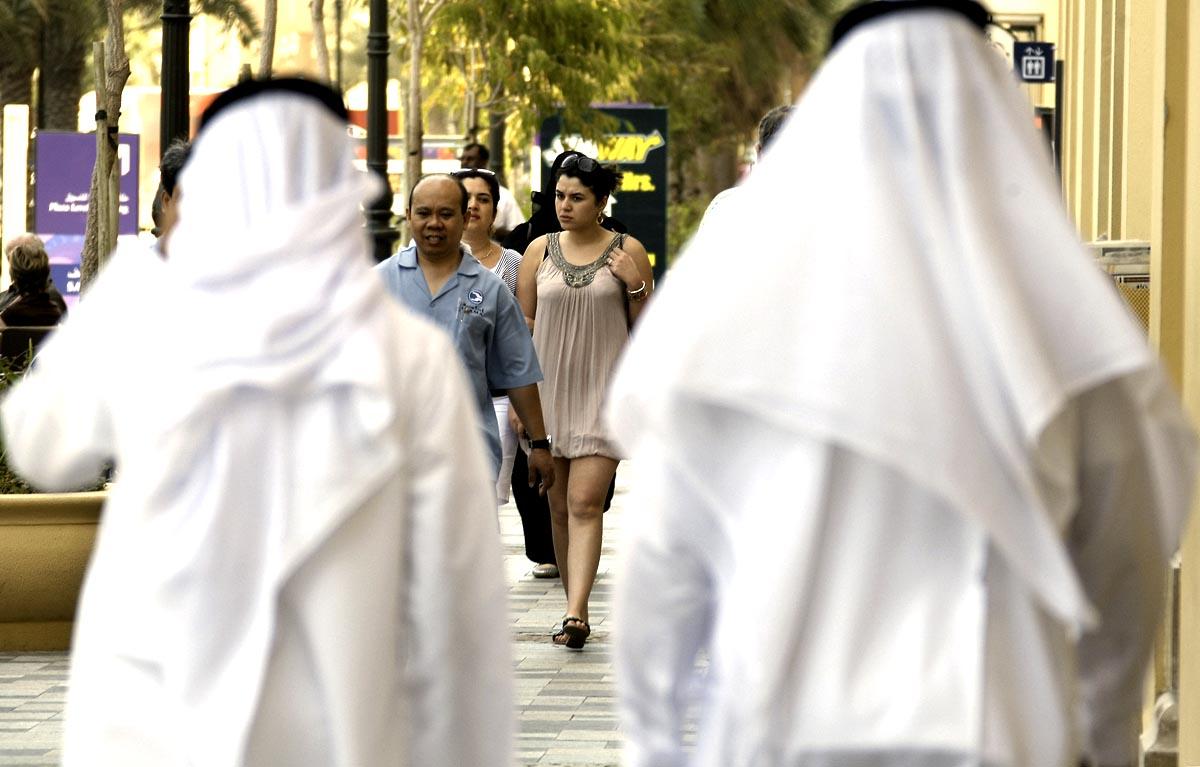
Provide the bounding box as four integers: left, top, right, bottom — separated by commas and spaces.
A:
376, 174, 554, 492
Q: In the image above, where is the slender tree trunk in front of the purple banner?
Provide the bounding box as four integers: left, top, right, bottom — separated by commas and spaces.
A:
79, 0, 130, 289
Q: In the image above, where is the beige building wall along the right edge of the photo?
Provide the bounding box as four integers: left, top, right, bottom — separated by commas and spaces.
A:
1051, 0, 1200, 767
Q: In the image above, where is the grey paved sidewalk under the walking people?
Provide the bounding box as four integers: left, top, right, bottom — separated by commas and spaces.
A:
0, 483, 624, 767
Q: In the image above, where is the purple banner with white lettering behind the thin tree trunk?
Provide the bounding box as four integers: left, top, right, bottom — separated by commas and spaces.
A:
34, 131, 138, 235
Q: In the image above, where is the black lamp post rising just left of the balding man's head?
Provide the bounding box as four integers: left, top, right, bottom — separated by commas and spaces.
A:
366, 0, 400, 260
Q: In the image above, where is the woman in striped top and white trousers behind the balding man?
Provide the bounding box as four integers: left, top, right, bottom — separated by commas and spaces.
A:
450, 168, 521, 505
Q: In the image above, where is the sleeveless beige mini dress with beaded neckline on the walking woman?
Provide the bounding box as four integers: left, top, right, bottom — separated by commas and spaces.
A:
533, 232, 629, 460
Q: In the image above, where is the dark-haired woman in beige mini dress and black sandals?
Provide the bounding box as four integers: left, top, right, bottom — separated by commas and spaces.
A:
517, 155, 653, 649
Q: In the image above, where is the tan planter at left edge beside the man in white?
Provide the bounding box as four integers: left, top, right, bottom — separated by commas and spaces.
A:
0, 491, 107, 651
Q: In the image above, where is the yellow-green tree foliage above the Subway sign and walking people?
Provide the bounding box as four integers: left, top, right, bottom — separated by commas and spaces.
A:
392, 0, 847, 220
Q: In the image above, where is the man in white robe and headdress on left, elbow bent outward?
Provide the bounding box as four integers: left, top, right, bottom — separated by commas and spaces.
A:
2, 80, 511, 767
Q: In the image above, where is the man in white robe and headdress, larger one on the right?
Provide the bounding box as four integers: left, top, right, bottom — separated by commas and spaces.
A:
608, 1, 1195, 767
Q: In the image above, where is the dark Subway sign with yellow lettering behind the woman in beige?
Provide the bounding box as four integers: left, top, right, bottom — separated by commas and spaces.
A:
534, 106, 668, 285
